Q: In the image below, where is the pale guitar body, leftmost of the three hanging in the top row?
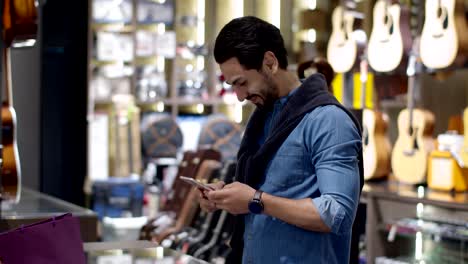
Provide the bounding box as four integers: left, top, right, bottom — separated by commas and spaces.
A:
327, 6, 357, 73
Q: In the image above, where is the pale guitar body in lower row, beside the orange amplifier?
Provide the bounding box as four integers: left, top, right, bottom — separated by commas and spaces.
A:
392, 109, 435, 184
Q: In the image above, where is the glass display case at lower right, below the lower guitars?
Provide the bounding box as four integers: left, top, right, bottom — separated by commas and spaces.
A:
362, 181, 468, 264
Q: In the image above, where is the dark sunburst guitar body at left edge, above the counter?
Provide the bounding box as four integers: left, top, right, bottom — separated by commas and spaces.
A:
1, 105, 21, 202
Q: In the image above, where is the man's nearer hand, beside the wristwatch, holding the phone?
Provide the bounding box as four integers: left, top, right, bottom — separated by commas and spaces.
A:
206, 182, 255, 214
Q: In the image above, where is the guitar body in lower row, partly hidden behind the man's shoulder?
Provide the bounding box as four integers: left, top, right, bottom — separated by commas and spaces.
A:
362, 109, 391, 180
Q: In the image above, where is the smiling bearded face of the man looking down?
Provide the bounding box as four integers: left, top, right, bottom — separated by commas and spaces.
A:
220, 57, 279, 107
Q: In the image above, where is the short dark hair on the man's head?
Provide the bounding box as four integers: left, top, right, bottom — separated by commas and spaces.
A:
214, 16, 288, 70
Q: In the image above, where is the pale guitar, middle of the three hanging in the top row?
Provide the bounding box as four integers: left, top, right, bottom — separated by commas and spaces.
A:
368, 0, 411, 72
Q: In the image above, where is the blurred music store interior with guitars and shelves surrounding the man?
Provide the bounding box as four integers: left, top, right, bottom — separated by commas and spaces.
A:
0, 0, 468, 264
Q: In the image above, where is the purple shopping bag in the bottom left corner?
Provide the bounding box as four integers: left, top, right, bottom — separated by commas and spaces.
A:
0, 213, 86, 264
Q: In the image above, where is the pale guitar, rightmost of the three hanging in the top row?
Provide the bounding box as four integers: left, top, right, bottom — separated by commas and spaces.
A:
421, 0, 468, 69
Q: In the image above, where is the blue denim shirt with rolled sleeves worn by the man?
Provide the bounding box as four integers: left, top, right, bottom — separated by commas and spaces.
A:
243, 104, 362, 264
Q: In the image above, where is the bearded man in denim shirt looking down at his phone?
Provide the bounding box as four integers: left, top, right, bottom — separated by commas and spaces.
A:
200, 17, 362, 264
